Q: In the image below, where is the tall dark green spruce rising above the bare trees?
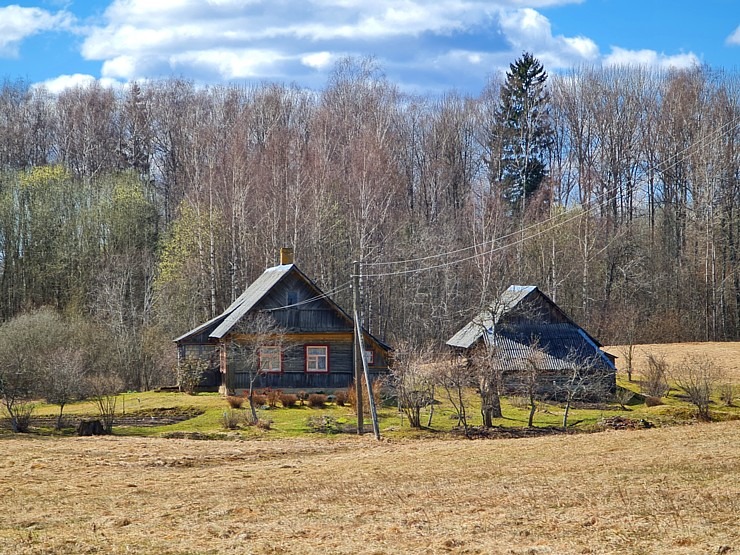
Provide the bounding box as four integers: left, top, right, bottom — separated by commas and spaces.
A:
491, 52, 553, 215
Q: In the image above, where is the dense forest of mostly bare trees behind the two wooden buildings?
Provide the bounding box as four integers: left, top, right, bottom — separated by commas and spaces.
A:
0, 54, 740, 387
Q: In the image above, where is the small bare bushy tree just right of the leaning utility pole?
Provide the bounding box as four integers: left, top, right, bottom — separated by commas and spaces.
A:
391, 343, 435, 428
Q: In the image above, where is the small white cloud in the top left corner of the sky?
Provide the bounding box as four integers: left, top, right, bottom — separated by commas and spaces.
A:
0, 5, 74, 57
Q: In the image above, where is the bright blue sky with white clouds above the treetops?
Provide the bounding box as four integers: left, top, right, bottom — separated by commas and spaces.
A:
0, 0, 740, 95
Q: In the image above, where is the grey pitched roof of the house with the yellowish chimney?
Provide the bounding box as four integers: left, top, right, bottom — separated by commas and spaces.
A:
174, 264, 391, 351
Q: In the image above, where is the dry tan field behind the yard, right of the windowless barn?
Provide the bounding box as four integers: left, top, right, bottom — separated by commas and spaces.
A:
604, 342, 740, 384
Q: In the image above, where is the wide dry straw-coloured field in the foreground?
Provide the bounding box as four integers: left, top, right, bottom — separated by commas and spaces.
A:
0, 421, 740, 555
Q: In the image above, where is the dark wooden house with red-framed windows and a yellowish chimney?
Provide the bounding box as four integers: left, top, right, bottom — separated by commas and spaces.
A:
174, 249, 390, 394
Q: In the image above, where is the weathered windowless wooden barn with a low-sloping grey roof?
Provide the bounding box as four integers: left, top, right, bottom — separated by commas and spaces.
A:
447, 285, 616, 400
